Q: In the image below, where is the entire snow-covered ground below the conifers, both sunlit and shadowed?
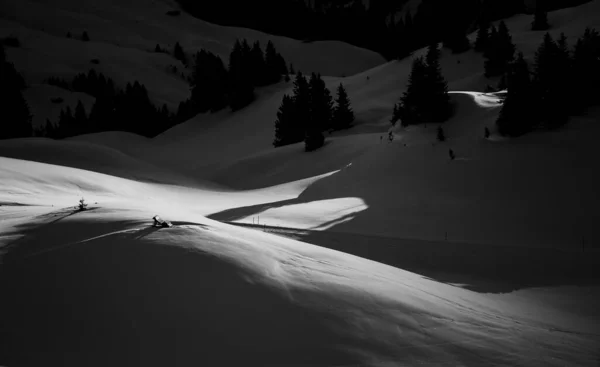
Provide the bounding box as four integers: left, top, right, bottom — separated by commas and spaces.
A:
0, 1, 600, 367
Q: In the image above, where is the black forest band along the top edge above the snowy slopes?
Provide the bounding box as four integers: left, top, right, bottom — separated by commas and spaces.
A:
177, 0, 589, 59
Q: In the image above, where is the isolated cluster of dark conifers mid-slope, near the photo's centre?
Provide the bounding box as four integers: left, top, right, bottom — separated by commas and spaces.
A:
273, 72, 354, 151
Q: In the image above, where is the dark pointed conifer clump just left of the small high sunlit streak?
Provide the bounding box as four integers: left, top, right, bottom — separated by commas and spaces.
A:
392, 43, 452, 126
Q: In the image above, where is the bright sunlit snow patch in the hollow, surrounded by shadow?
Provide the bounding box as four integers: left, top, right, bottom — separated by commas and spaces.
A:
236, 197, 368, 230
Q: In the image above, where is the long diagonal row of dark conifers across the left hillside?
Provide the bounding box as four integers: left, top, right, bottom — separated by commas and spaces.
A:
36, 39, 291, 139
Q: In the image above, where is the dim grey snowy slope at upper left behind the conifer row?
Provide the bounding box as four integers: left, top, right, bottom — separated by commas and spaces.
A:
0, 0, 384, 123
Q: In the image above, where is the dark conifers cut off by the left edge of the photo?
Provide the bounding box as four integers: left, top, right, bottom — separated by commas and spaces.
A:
0, 44, 33, 139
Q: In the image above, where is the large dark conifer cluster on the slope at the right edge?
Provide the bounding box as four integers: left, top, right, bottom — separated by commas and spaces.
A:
497, 28, 600, 136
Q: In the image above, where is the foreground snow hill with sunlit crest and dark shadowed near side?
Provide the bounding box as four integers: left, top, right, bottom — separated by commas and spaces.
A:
0, 159, 598, 366
